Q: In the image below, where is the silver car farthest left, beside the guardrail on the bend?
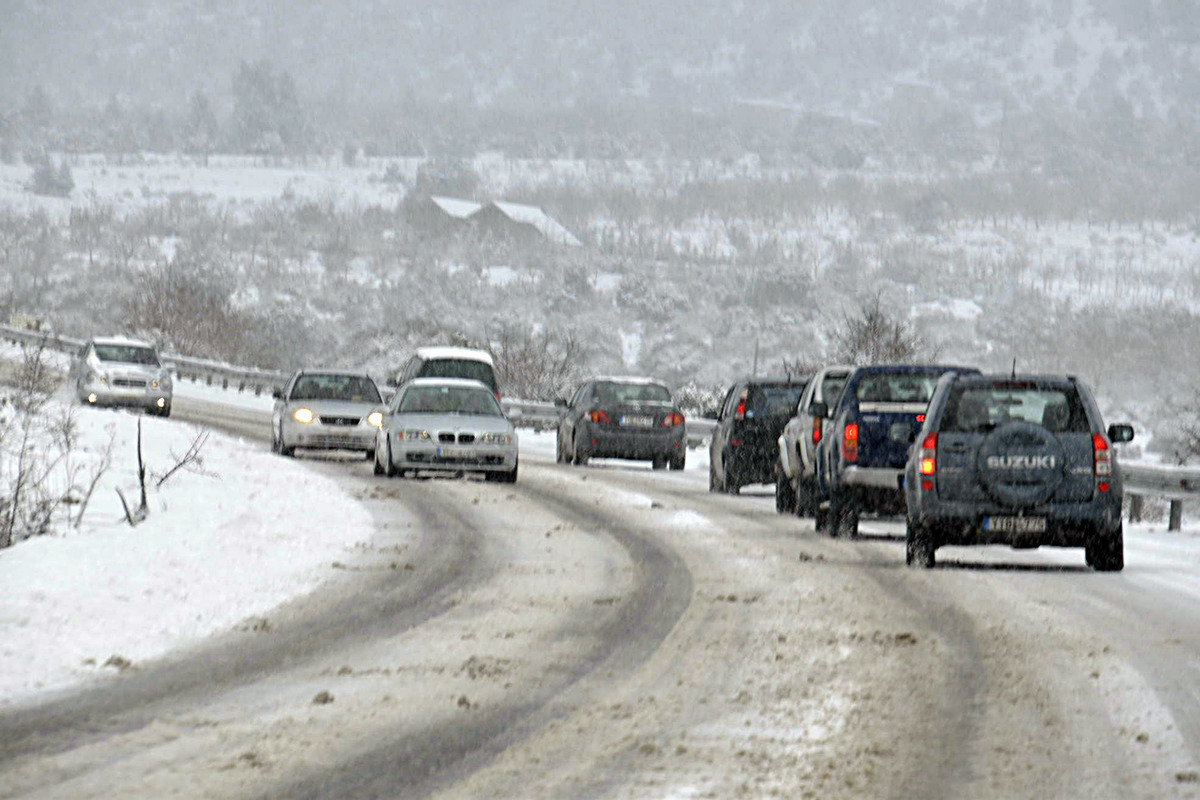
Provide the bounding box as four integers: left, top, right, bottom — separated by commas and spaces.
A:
67, 336, 173, 416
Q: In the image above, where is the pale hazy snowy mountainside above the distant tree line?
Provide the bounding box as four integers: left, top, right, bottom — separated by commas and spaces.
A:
9, 0, 1200, 124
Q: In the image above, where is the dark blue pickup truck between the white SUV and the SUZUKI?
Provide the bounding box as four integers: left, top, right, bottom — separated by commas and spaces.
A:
809, 365, 979, 536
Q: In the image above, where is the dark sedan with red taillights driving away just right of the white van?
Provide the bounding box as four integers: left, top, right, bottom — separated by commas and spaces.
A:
557, 378, 688, 469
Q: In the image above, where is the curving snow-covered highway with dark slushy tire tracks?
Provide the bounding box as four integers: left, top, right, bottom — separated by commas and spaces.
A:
0, 399, 1200, 799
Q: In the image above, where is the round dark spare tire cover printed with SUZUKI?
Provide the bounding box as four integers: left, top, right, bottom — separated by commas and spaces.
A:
976, 422, 1067, 506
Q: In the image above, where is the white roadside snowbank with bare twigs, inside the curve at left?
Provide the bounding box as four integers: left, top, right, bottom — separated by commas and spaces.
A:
0, 408, 372, 708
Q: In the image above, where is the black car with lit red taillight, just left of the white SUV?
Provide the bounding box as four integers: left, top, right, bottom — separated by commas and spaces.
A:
708, 375, 812, 494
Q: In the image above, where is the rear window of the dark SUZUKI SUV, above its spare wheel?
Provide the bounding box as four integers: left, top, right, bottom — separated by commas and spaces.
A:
941, 383, 1091, 433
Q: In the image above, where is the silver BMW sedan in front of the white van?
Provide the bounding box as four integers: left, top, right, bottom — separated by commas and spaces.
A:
374, 378, 517, 483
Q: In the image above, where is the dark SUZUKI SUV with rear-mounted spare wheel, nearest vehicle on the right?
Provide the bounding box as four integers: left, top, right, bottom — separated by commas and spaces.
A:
905, 375, 1133, 571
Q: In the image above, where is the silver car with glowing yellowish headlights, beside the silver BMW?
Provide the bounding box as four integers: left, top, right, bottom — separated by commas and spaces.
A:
271, 369, 383, 458
